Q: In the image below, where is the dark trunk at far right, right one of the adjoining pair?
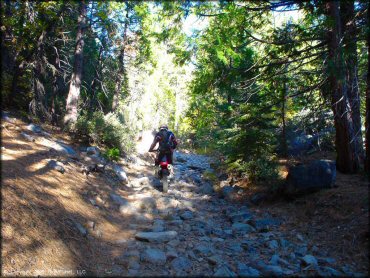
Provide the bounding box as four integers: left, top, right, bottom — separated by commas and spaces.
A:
340, 0, 364, 160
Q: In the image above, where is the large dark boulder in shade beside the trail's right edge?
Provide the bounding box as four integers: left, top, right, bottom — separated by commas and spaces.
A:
284, 160, 336, 195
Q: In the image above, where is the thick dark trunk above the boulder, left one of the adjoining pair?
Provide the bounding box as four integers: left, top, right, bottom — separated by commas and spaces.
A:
326, 1, 360, 173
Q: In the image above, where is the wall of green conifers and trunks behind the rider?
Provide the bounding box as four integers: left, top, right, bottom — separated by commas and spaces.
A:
1, 0, 370, 182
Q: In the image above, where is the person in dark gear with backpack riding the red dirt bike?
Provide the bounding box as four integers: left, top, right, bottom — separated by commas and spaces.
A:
149, 125, 177, 165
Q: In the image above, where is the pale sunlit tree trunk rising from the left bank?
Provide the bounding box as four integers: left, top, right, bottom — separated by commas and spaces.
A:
64, 0, 87, 125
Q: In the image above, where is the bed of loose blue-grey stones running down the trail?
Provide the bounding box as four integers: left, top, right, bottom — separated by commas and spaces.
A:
112, 152, 350, 277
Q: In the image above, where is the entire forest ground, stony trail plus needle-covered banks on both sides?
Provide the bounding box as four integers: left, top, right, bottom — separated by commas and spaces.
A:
1, 112, 369, 277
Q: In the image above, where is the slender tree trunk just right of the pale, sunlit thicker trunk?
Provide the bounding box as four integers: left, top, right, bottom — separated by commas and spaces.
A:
112, 2, 130, 112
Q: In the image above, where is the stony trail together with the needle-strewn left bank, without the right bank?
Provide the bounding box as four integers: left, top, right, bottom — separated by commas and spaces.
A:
2, 112, 366, 277
